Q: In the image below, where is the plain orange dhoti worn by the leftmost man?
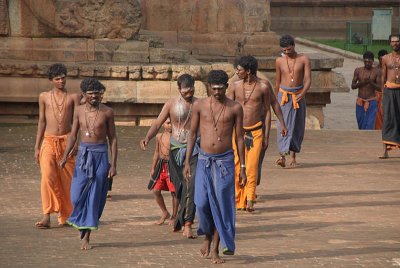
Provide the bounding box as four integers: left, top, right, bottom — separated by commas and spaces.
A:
40, 134, 75, 224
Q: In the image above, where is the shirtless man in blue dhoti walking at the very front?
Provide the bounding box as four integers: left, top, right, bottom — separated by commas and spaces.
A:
184, 70, 247, 264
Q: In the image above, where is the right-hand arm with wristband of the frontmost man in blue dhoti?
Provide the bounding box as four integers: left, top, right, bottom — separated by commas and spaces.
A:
235, 103, 247, 188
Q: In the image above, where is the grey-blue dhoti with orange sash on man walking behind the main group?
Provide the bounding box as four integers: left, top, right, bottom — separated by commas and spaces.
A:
277, 85, 306, 155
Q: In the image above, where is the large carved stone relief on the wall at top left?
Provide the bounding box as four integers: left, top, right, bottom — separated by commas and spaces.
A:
16, 0, 141, 39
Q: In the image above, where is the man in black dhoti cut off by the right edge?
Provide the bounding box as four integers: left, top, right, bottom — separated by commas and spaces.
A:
380, 34, 400, 159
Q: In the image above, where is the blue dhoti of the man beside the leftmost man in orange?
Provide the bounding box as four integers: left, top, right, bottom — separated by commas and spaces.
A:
67, 142, 109, 230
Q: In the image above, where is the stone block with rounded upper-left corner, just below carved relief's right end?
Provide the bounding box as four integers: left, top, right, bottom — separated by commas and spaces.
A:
112, 41, 150, 63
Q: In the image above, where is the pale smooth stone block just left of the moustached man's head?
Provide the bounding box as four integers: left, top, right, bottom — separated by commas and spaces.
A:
137, 81, 173, 103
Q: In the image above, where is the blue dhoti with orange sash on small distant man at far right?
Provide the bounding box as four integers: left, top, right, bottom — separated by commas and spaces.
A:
356, 97, 378, 129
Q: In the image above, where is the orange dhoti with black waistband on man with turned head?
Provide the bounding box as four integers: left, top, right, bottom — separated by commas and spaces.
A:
233, 121, 263, 209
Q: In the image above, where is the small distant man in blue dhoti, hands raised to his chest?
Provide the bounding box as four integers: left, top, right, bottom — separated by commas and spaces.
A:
351, 51, 381, 129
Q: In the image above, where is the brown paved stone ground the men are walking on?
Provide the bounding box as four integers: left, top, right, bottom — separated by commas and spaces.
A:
0, 125, 400, 268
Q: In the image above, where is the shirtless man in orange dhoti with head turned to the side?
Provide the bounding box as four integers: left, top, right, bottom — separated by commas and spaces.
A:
228, 56, 287, 212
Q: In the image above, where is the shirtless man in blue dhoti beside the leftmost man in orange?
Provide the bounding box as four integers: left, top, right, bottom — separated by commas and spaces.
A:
59, 78, 117, 250
